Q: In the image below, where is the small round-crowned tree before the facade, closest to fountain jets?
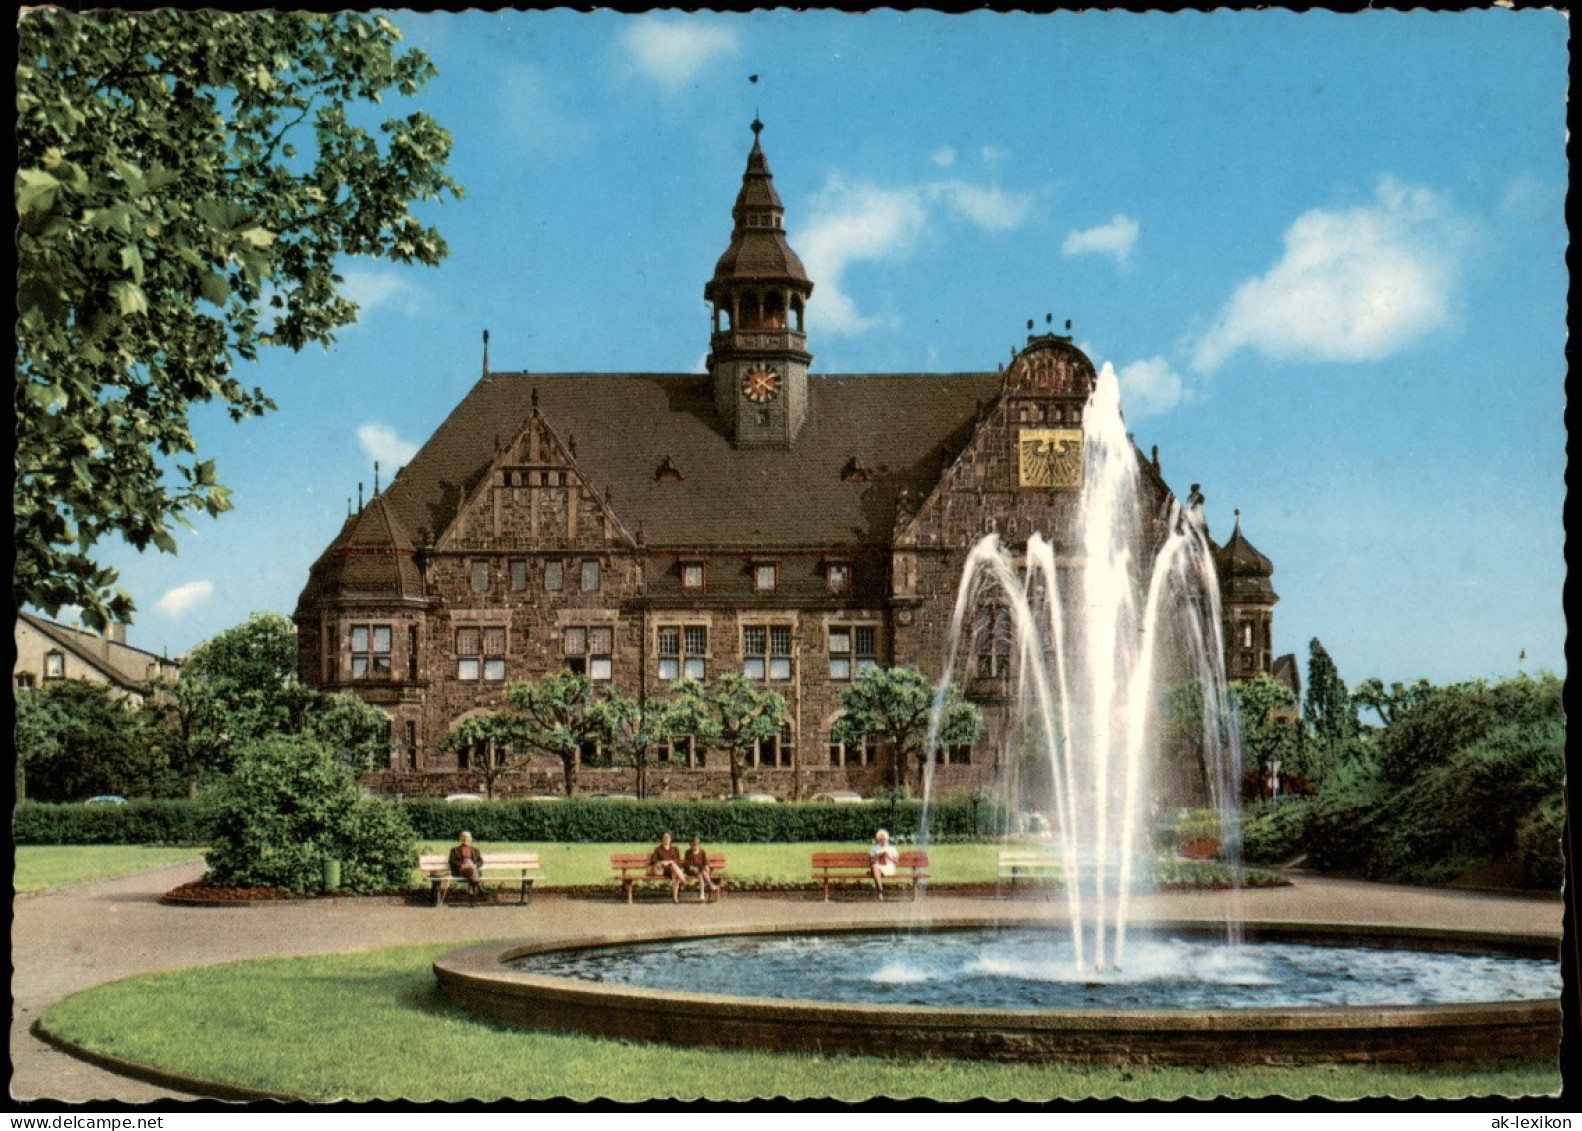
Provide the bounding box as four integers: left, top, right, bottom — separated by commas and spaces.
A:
831, 668, 984, 789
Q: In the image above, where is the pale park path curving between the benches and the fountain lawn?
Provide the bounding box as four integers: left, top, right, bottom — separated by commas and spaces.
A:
11, 861, 1561, 1103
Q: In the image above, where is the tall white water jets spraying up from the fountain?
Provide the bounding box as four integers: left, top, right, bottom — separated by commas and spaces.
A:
924, 364, 1240, 973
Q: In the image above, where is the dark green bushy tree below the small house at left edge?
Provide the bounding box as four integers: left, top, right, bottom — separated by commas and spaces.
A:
16, 680, 163, 800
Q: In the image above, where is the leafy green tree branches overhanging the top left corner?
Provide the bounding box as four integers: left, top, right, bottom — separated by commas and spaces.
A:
13, 8, 460, 628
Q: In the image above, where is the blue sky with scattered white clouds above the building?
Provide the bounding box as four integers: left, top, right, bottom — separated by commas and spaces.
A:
89, 9, 1568, 683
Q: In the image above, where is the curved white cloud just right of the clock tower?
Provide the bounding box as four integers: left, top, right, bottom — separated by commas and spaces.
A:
796, 176, 1028, 334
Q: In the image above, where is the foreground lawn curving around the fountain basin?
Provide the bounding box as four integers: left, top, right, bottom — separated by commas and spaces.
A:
46, 943, 1560, 1101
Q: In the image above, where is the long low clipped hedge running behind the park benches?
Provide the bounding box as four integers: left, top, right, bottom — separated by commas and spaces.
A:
402, 799, 1006, 845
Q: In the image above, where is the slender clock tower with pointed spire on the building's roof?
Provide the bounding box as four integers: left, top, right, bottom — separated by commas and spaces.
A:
702, 119, 813, 448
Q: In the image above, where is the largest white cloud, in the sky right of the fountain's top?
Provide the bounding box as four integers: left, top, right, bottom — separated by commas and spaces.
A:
1193, 177, 1468, 372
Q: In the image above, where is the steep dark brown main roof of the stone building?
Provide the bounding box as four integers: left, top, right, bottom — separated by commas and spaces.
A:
378, 373, 1001, 557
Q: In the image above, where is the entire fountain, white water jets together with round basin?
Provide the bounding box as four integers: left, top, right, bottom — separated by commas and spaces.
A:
433, 349, 1560, 1065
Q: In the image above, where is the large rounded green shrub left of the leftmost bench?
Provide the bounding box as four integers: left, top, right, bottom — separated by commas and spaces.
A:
207, 736, 418, 892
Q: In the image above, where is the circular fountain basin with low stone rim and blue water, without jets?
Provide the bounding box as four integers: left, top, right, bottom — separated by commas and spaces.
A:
433, 917, 1560, 1065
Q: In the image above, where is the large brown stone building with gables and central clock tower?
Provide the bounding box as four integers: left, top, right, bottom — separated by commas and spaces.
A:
294, 122, 1275, 797
